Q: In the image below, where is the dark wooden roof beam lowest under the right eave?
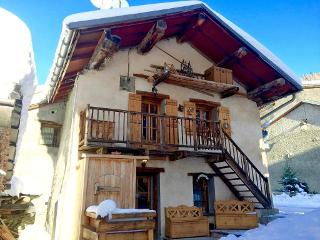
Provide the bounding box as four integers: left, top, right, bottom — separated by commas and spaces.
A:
248, 78, 286, 100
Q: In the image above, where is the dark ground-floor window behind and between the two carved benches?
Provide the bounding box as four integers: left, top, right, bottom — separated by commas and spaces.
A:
193, 173, 214, 215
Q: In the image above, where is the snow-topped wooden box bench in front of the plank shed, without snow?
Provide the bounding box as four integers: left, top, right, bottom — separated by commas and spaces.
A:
82, 212, 156, 240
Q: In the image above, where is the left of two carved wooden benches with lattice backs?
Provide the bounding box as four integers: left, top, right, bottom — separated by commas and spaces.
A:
165, 205, 209, 238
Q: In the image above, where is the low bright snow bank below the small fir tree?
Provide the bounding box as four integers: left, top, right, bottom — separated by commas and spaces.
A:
273, 193, 320, 210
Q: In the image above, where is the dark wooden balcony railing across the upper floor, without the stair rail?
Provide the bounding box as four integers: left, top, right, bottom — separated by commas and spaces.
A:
80, 105, 221, 151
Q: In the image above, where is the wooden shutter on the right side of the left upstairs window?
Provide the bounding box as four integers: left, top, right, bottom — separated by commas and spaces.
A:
164, 99, 179, 144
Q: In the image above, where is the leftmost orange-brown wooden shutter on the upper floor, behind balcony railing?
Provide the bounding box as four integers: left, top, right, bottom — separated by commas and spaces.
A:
128, 93, 142, 143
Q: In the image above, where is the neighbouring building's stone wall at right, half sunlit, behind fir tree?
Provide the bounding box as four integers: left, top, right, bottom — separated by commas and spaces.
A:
267, 103, 320, 192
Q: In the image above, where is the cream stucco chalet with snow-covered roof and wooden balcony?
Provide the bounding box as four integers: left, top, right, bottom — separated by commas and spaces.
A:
16, 1, 301, 239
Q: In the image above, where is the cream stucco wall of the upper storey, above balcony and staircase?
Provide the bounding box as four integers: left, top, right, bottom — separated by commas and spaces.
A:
77, 39, 267, 174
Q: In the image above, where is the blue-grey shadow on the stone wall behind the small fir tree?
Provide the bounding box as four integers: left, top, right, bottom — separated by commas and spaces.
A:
269, 147, 320, 192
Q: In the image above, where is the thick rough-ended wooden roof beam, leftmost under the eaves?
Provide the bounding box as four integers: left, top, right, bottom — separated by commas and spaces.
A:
88, 29, 121, 70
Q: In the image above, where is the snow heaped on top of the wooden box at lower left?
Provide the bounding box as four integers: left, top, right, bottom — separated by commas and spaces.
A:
86, 199, 155, 219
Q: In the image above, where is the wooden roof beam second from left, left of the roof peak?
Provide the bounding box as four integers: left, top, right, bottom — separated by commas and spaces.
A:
138, 19, 167, 54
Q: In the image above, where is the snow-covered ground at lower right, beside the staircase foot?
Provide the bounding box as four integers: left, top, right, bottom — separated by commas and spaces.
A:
222, 193, 320, 240
